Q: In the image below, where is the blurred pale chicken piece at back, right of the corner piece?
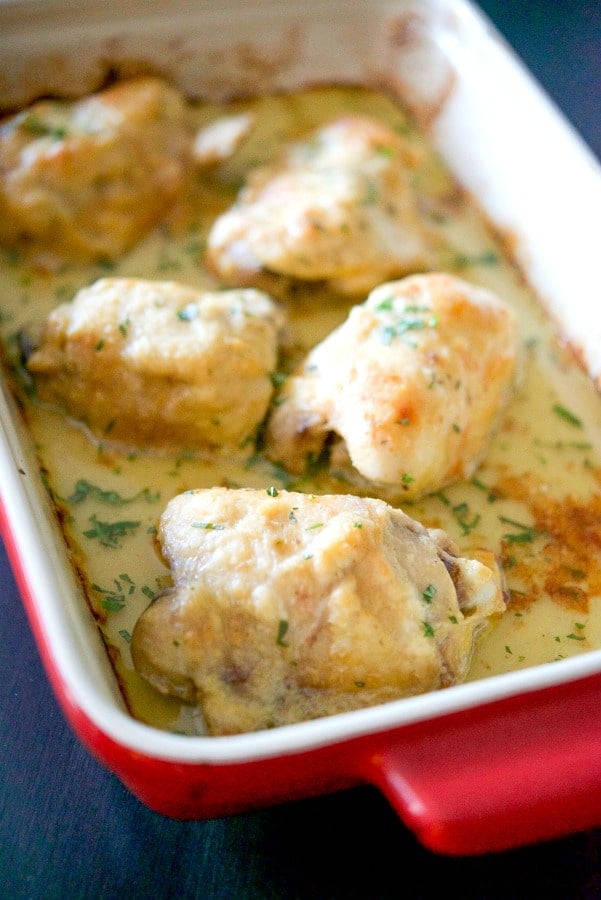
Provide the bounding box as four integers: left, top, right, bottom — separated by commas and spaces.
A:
206, 115, 428, 293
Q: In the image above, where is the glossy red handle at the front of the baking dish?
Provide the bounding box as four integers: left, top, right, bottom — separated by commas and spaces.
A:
364, 675, 601, 855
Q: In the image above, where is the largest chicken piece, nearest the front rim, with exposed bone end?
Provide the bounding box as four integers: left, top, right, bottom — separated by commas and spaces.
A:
131, 488, 505, 735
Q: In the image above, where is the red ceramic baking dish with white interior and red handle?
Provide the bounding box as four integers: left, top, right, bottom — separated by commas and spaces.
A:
0, 2, 601, 853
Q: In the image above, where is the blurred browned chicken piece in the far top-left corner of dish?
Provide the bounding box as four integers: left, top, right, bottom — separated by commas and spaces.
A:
0, 77, 194, 260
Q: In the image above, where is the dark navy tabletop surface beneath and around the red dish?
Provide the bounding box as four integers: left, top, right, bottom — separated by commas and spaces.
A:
0, 0, 601, 900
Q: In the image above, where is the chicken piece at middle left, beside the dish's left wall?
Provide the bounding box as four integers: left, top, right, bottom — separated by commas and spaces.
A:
27, 278, 284, 449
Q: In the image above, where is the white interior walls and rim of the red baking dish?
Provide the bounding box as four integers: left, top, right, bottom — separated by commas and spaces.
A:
0, 0, 601, 763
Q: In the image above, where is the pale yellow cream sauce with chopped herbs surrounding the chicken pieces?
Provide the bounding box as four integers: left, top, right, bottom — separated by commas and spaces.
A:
0, 87, 601, 734
